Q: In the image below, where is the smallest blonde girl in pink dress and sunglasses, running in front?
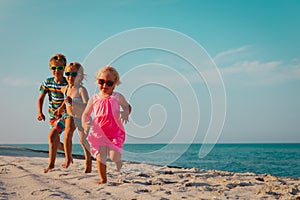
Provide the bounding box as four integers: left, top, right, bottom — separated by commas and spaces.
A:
82, 66, 131, 184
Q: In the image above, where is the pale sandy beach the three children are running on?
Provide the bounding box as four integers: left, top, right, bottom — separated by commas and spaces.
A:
0, 147, 300, 200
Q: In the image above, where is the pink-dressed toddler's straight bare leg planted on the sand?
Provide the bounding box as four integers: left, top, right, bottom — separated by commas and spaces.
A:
96, 147, 107, 184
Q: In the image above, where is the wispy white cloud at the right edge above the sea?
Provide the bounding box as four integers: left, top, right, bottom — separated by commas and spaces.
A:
212, 46, 300, 87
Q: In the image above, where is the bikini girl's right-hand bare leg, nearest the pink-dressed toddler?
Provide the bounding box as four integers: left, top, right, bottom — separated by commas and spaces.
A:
78, 129, 92, 173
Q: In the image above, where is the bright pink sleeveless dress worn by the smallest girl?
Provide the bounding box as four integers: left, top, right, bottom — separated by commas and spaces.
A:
87, 92, 125, 158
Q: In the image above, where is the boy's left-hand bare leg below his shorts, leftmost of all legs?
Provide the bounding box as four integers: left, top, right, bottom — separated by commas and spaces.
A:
44, 128, 59, 173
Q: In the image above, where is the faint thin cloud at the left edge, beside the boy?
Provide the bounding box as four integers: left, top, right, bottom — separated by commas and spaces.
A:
0, 76, 39, 87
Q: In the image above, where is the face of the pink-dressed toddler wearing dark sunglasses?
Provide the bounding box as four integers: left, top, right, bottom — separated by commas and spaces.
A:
97, 71, 115, 95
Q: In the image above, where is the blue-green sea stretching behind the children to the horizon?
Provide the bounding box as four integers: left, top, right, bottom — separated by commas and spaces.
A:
0, 143, 300, 178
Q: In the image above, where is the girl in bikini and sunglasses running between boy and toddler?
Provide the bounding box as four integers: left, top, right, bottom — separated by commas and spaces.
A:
62, 62, 92, 173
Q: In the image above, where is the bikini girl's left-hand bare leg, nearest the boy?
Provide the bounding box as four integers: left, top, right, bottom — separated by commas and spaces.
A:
61, 118, 75, 168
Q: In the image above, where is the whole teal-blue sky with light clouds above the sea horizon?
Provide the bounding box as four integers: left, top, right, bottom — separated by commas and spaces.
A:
0, 0, 300, 144
